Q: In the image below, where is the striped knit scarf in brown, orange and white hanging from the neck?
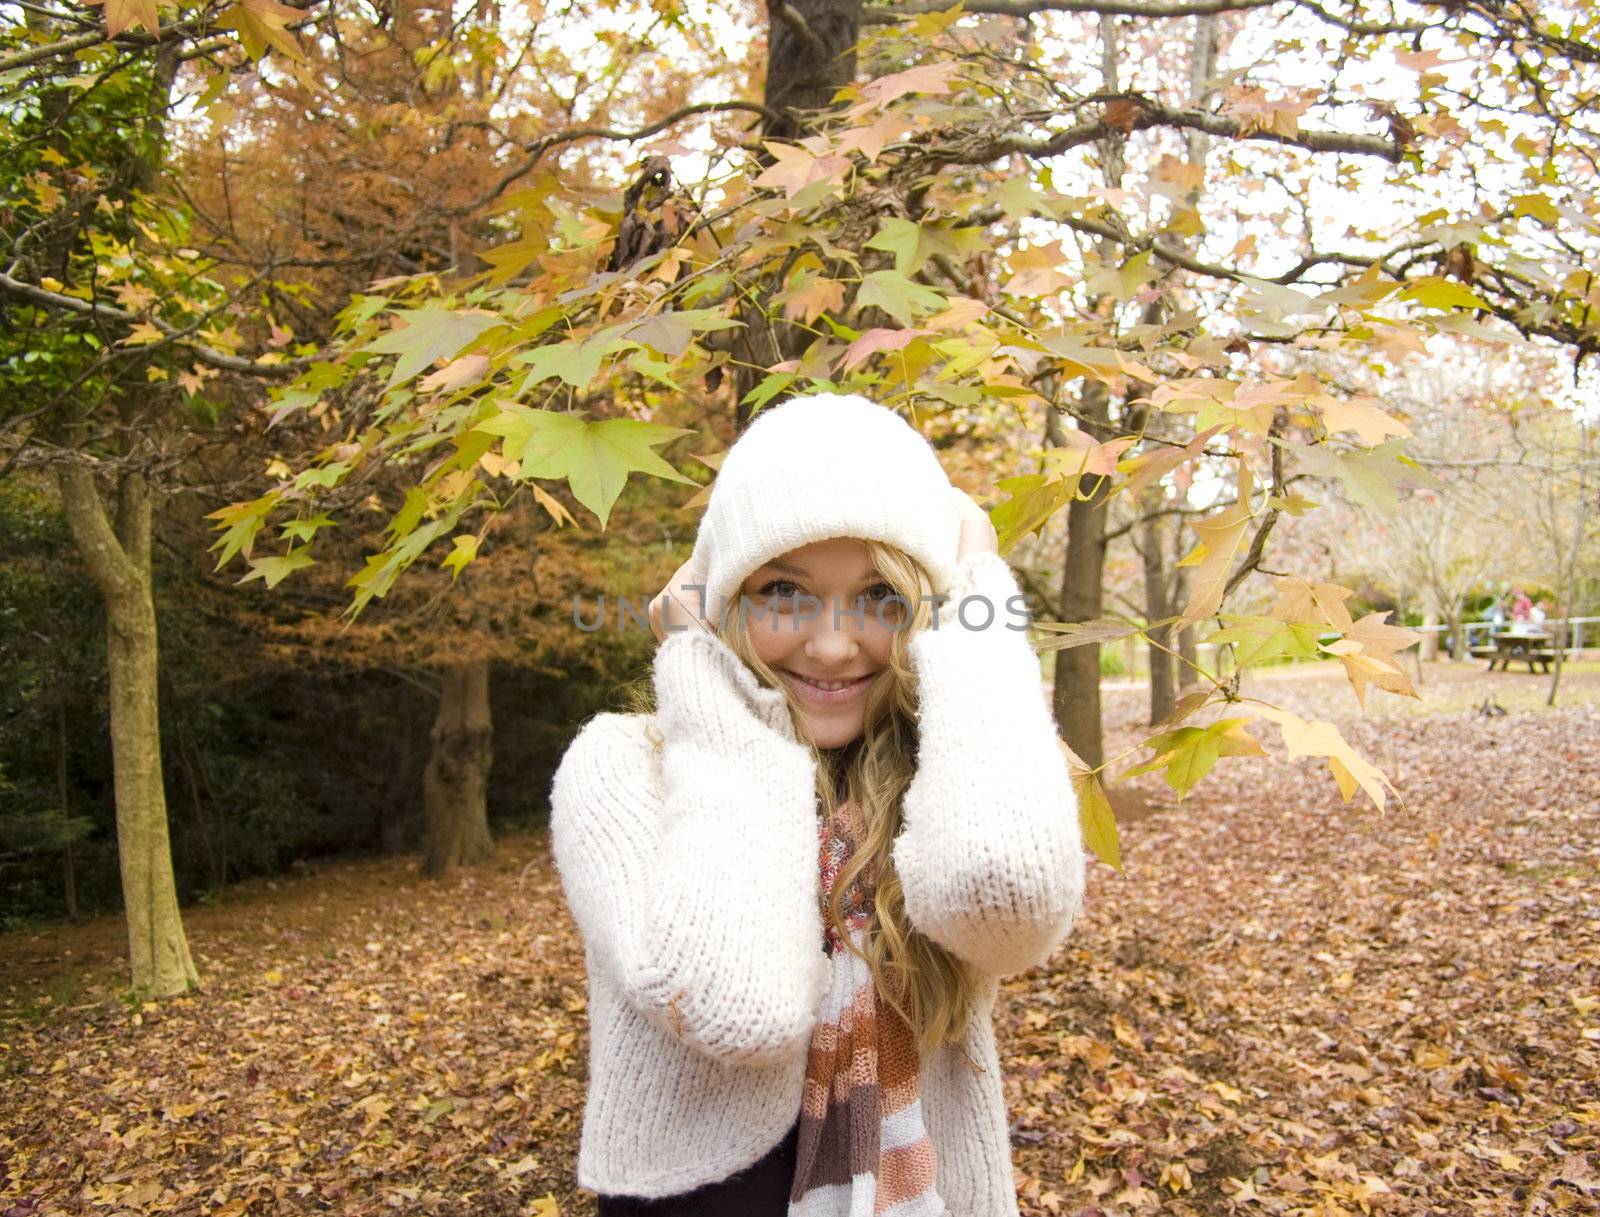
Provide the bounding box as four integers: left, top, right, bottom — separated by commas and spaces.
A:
789, 801, 946, 1217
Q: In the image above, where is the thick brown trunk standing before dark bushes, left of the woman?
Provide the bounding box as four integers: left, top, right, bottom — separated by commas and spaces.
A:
422, 659, 494, 878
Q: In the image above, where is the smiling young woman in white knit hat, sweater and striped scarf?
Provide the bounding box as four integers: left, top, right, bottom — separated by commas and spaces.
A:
550, 395, 1083, 1217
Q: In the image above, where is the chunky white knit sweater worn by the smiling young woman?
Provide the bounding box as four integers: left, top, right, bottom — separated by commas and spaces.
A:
550, 553, 1083, 1217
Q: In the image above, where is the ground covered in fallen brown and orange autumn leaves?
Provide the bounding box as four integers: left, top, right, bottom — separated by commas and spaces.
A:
0, 664, 1600, 1217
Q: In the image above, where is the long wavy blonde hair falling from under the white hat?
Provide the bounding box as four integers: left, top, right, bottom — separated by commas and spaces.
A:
624, 539, 982, 1054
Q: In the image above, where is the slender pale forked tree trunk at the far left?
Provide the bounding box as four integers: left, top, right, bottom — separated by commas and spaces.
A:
58, 450, 200, 996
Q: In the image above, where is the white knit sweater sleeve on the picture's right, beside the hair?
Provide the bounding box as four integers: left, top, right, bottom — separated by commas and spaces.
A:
894, 553, 1085, 976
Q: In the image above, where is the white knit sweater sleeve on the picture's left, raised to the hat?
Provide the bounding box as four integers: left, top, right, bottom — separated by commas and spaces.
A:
550, 630, 830, 1063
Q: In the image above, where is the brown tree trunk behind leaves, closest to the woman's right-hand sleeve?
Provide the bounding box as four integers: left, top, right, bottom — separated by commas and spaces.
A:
1051, 381, 1110, 769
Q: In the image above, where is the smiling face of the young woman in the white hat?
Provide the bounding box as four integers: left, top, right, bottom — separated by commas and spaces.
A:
739, 537, 907, 748
